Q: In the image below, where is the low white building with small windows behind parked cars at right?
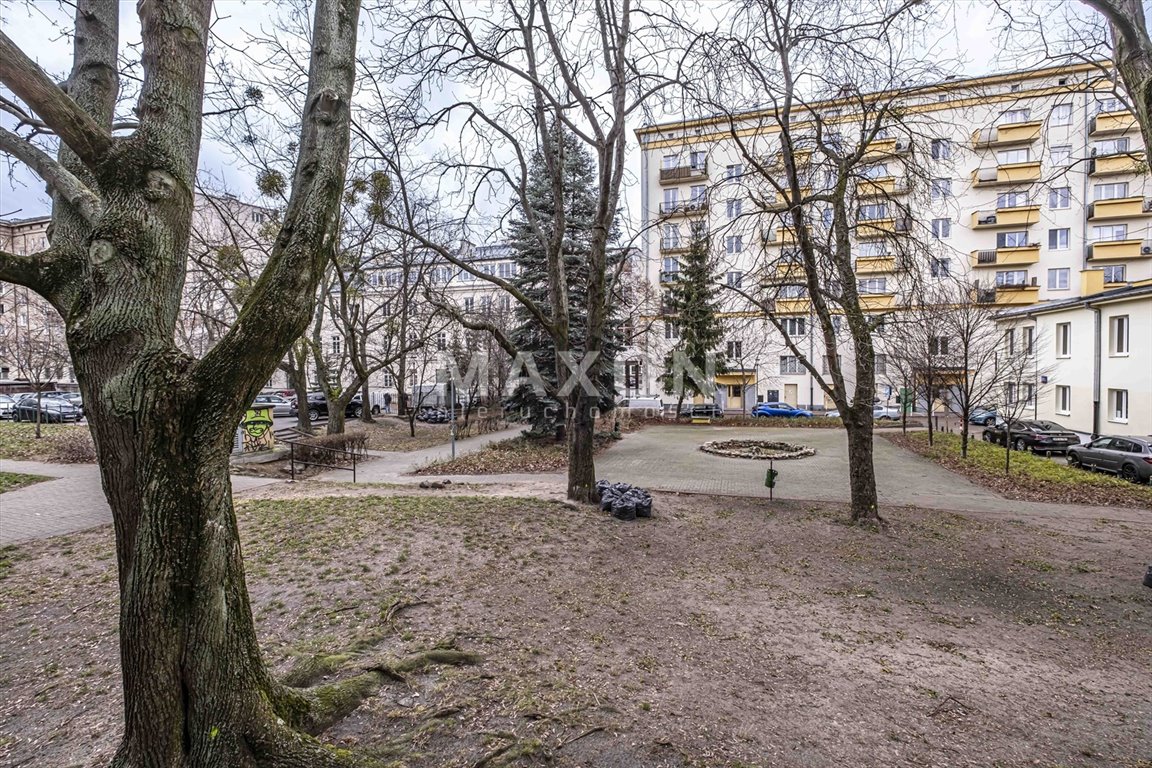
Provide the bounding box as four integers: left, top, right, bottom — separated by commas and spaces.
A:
999, 269, 1152, 436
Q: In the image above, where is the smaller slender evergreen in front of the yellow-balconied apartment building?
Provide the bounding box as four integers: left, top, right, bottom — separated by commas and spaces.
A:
660, 233, 726, 416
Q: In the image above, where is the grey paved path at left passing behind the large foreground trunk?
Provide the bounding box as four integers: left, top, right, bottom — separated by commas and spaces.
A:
0, 459, 281, 545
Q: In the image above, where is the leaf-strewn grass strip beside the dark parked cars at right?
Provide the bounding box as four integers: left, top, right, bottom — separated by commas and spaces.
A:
887, 432, 1152, 509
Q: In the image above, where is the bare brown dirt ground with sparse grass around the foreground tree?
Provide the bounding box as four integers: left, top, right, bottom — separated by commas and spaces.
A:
0, 486, 1152, 768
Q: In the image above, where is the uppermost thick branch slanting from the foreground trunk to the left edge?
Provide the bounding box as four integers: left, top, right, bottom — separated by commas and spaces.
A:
0, 32, 112, 168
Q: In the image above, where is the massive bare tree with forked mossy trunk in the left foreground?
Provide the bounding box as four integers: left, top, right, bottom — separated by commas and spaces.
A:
0, 0, 370, 768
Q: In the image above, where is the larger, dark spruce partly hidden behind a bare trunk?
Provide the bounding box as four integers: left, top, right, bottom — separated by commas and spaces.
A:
505, 131, 624, 436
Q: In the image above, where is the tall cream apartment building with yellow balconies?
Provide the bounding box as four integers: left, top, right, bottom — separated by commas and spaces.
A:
637, 63, 1152, 434
